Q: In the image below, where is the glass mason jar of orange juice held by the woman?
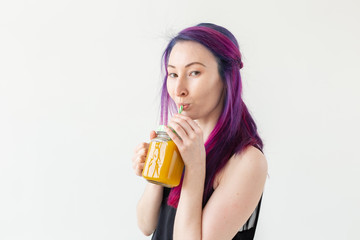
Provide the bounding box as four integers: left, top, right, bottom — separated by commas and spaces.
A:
142, 125, 184, 188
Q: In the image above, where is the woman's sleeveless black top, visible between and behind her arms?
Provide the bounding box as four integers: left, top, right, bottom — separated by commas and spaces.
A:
151, 187, 262, 240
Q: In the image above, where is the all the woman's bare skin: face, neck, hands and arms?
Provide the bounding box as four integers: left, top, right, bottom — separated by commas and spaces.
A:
133, 41, 267, 240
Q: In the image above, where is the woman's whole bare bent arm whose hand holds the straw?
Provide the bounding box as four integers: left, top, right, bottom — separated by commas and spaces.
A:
167, 116, 267, 240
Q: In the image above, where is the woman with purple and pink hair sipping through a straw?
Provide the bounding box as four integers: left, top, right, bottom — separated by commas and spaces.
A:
133, 23, 267, 240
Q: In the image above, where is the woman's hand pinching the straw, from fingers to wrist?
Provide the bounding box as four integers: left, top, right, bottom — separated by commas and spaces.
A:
165, 114, 206, 169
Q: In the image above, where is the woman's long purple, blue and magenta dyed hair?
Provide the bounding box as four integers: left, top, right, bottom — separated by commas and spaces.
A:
160, 23, 263, 208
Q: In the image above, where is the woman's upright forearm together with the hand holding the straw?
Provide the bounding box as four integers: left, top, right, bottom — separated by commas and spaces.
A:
166, 114, 206, 240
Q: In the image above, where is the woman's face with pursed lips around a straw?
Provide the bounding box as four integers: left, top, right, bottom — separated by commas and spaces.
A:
167, 41, 224, 121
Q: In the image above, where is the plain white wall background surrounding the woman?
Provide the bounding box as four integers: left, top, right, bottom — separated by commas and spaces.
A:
0, 0, 360, 240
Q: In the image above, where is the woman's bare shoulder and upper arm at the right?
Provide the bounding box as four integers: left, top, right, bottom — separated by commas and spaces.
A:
202, 146, 267, 239
